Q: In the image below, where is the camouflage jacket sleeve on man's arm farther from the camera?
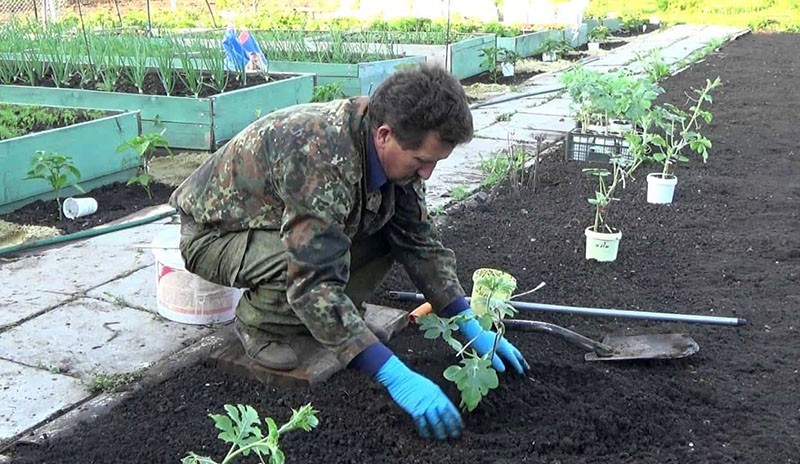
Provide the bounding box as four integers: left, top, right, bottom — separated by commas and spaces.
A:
385, 179, 464, 312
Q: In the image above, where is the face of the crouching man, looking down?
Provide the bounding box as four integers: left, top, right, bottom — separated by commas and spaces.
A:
374, 124, 453, 185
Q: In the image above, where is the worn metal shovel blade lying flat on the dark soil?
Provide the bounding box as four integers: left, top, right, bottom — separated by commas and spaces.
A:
584, 334, 700, 361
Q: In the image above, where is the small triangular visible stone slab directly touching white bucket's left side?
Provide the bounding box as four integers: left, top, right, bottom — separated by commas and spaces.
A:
87, 266, 158, 313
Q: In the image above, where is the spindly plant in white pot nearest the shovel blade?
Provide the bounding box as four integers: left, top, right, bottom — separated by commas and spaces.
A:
583, 153, 629, 262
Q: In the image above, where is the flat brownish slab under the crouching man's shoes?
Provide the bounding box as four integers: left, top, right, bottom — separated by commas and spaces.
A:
206, 305, 408, 388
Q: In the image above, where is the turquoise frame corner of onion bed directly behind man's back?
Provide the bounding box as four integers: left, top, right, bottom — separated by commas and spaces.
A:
0, 74, 314, 150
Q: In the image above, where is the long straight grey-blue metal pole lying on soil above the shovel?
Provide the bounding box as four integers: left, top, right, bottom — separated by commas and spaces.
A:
389, 291, 747, 326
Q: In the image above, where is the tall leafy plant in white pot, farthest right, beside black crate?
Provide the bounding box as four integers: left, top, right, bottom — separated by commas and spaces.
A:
633, 77, 722, 204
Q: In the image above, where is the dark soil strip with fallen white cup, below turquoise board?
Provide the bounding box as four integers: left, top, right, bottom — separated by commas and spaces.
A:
0, 183, 175, 234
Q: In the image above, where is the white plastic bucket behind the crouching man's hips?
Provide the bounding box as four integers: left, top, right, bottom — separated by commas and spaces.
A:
152, 226, 242, 324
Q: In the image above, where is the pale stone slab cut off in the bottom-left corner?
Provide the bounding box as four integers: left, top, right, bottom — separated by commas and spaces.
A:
0, 358, 91, 442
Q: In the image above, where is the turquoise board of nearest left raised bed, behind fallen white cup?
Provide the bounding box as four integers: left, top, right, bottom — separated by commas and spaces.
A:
0, 111, 141, 214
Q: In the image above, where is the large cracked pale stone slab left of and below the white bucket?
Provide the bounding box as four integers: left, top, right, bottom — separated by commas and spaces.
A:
0, 298, 211, 380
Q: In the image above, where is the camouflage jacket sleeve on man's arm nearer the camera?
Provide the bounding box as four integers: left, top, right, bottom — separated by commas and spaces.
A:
273, 126, 378, 366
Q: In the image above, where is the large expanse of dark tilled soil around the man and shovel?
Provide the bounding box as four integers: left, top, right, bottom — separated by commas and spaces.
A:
7, 35, 800, 464
